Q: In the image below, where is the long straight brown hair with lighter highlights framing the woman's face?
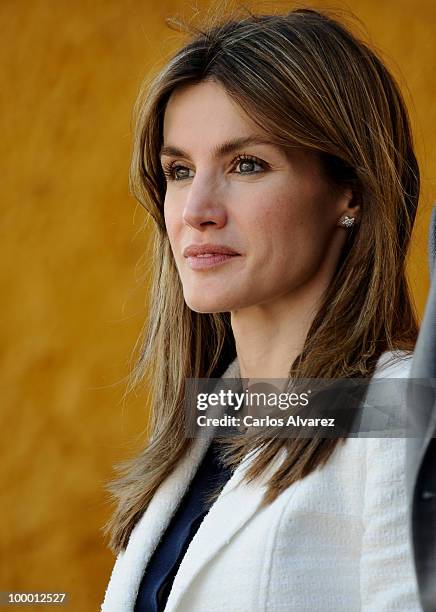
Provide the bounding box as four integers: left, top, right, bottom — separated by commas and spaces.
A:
105, 4, 420, 552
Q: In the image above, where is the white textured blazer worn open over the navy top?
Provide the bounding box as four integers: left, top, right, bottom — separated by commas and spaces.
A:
101, 353, 422, 612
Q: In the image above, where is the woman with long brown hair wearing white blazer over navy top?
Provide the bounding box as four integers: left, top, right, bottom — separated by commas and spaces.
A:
102, 9, 420, 612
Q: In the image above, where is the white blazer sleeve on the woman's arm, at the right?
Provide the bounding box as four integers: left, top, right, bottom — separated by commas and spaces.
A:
356, 438, 422, 612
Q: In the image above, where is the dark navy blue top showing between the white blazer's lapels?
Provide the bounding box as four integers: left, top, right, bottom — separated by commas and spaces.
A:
135, 440, 231, 612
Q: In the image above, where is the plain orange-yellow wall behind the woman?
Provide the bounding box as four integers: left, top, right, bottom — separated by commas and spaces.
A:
0, 0, 436, 612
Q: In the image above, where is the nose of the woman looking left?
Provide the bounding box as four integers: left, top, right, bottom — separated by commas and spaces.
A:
183, 172, 227, 230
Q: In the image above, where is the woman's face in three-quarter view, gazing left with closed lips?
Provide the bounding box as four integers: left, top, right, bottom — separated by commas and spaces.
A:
161, 81, 351, 312
